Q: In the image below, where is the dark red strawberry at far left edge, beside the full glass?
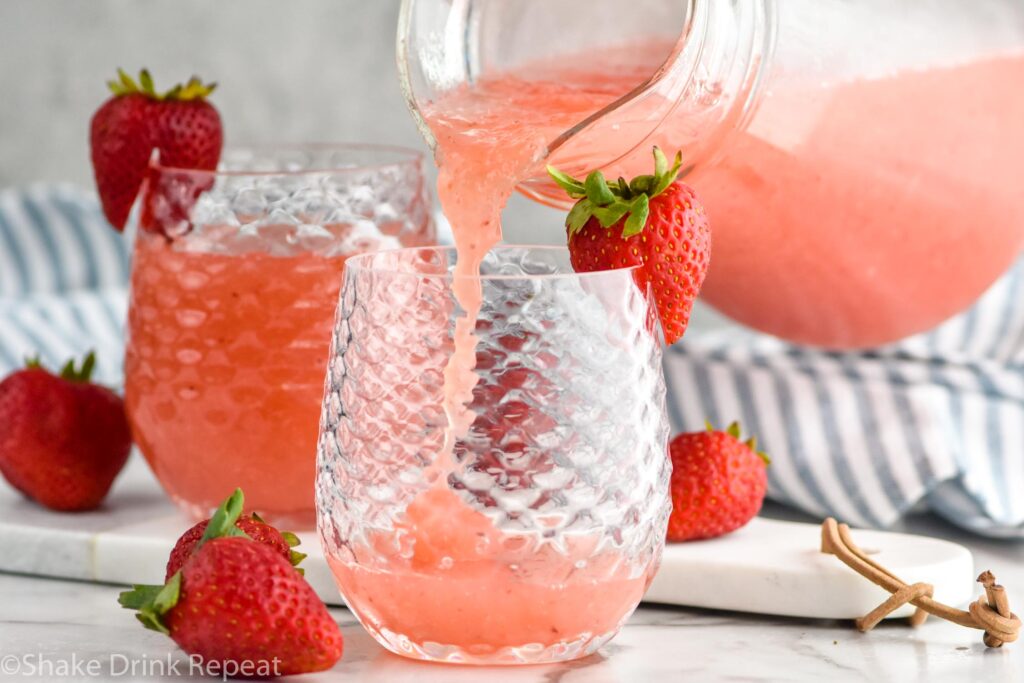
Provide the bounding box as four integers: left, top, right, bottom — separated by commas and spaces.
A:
0, 353, 131, 512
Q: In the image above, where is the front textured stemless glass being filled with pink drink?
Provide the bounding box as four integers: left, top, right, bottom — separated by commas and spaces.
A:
316, 247, 670, 664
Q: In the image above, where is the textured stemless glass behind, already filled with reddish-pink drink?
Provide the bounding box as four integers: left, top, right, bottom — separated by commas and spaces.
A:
125, 145, 434, 527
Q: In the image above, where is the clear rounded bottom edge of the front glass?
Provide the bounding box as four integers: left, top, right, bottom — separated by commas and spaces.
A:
362, 624, 618, 667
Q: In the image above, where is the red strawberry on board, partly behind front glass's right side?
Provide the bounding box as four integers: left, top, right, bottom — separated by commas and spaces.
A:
668, 423, 769, 541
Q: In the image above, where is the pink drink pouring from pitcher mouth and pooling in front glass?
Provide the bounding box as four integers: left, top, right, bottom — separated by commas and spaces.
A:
329, 49, 652, 654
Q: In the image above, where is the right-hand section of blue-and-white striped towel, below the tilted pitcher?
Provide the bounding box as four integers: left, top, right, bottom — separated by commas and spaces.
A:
665, 261, 1024, 538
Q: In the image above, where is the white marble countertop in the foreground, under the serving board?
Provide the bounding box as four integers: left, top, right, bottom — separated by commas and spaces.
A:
0, 509, 1024, 683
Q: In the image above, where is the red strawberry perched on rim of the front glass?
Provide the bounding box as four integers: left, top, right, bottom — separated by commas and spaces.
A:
548, 147, 711, 344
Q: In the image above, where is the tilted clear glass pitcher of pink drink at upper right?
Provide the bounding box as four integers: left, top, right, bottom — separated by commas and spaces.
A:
398, 0, 1024, 348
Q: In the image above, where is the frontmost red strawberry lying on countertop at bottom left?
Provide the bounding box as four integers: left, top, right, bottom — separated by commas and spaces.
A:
118, 492, 344, 676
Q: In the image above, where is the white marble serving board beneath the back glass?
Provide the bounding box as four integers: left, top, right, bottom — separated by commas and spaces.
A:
0, 454, 975, 618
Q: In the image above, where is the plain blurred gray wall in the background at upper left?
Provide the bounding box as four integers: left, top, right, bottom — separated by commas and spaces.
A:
0, 0, 564, 243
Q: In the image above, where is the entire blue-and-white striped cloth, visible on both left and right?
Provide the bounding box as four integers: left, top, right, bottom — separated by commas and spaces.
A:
0, 186, 1024, 538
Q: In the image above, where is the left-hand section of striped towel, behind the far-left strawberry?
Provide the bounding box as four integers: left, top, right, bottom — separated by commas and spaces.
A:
0, 185, 129, 386
